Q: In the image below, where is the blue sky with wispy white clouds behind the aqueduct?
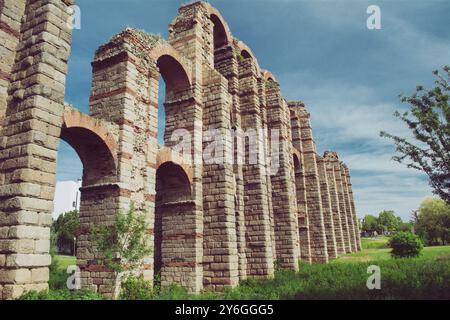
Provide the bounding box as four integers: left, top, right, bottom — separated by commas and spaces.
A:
58, 0, 450, 220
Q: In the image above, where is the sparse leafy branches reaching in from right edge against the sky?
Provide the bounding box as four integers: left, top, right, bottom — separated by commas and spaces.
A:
381, 66, 450, 204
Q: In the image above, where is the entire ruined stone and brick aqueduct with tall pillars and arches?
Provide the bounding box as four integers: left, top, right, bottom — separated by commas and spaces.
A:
0, 0, 361, 299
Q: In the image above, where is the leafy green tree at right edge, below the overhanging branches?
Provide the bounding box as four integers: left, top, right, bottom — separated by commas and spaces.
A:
415, 198, 450, 245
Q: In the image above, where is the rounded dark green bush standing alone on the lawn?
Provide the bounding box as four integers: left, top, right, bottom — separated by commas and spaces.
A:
389, 231, 423, 258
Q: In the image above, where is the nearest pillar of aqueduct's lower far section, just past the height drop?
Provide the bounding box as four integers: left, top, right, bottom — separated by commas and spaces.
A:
317, 156, 338, 259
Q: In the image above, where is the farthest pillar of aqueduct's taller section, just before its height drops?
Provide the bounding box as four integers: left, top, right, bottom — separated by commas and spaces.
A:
299, 108, 328, 262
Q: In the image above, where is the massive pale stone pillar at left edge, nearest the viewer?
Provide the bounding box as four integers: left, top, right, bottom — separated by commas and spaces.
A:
0, 0, 72, 299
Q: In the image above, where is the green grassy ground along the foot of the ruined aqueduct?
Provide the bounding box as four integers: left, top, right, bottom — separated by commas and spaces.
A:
25, 242, 450, 300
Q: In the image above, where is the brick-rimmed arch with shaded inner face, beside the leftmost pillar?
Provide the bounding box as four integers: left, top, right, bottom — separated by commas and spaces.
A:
57, 105, 122, 294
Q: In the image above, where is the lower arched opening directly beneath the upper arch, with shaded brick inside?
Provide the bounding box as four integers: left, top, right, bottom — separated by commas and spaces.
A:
154, 162, 196, 287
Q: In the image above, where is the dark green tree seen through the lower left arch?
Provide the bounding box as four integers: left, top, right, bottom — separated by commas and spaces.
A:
51, 210, 80, 254
